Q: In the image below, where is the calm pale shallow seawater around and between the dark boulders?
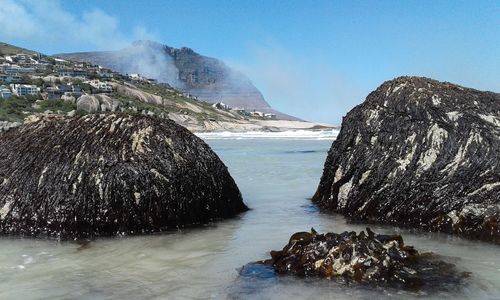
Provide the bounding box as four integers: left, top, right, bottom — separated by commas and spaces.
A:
0, 139, 500, 299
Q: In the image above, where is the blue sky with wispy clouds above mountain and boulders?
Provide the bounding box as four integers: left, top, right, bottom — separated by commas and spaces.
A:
0, 0, 500, 124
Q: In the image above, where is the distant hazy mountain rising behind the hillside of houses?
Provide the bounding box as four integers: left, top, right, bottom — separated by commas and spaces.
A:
55, 41, 296, 119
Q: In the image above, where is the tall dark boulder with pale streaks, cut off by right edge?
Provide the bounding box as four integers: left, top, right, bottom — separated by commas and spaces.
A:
313, 77, 500, 243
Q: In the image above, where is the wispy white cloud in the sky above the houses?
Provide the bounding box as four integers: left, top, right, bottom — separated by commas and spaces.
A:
0, 0, 153, 50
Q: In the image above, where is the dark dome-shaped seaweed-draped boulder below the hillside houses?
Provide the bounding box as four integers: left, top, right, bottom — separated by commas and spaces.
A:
0, 114, 247, 238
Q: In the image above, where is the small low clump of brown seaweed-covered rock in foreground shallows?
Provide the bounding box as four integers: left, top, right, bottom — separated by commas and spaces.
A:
263, 228, 468, 289
